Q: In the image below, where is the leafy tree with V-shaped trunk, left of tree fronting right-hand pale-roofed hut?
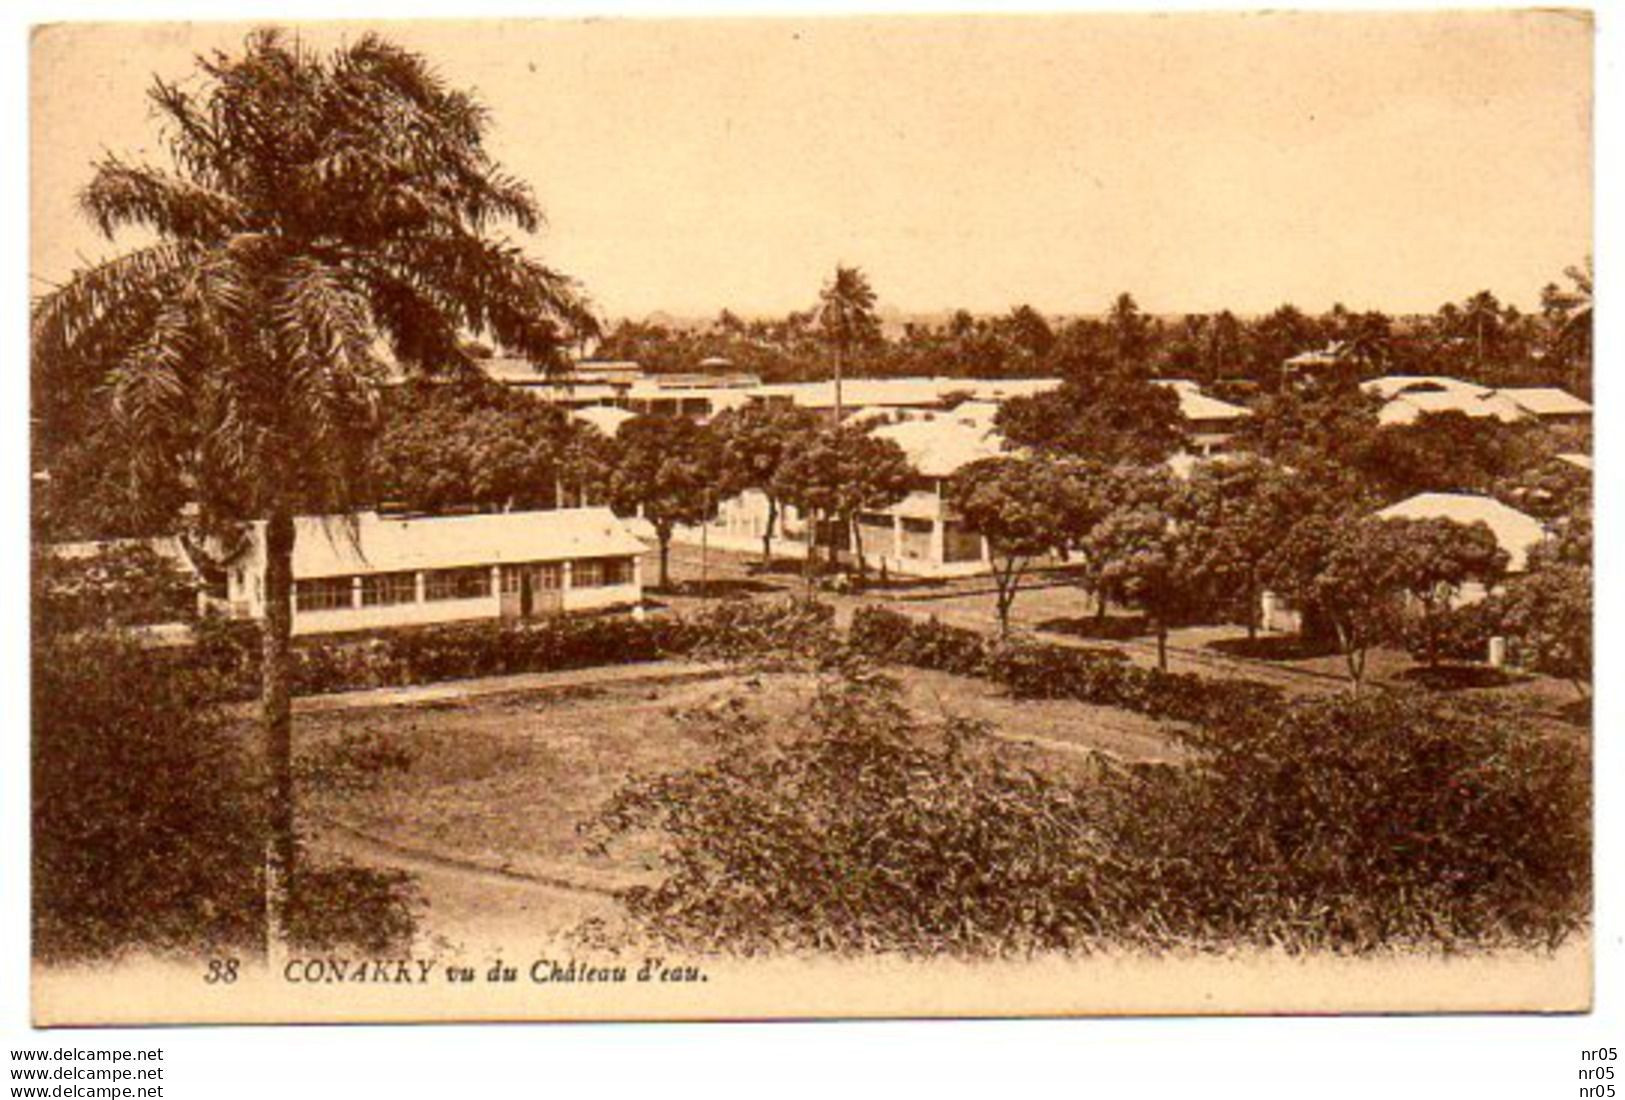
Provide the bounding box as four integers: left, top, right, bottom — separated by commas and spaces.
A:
1271, 513, 1406, 692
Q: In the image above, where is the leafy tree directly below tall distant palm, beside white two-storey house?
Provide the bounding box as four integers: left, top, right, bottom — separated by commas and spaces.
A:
774, 424, 915, 574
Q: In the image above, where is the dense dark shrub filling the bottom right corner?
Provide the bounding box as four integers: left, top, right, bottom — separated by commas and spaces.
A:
1163, 691, 1591, 951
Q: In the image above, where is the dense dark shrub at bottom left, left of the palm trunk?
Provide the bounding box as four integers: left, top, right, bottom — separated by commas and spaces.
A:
33, 634, 263, 960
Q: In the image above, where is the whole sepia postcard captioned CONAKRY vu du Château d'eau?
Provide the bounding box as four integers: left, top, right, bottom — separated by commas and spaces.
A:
28, 10, 1612, 1026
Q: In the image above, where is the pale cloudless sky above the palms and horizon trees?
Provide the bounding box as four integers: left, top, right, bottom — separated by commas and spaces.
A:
31, 11, 1591, 317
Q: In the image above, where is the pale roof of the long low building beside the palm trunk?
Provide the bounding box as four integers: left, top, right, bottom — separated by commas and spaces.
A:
294, 509, 644, 578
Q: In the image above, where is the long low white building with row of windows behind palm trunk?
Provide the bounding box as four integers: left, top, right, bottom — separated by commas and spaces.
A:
226, 509, 645, 634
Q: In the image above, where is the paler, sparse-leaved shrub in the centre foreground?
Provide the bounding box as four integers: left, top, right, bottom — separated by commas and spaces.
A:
596, 678, 1131, 955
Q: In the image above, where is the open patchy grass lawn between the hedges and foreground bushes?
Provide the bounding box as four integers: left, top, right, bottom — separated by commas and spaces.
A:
299, 671, 1180, 889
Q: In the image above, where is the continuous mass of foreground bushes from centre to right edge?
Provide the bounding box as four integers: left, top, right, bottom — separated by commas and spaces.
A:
595, 674, 1591, 957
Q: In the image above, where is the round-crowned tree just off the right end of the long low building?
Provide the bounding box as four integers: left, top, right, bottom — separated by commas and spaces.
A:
603, 416, 718, 588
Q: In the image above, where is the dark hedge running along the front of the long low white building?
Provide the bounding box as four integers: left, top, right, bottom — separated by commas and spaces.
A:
185, 600, 834, 700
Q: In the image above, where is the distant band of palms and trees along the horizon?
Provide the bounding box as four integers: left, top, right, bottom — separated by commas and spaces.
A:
596, 272, 1593, 395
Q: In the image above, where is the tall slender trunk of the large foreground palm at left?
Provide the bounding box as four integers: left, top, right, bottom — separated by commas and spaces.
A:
260, 502, 297, 959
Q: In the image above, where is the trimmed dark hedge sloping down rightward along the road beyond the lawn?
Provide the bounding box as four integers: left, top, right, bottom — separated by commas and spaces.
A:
850, 606, 1282, 726
